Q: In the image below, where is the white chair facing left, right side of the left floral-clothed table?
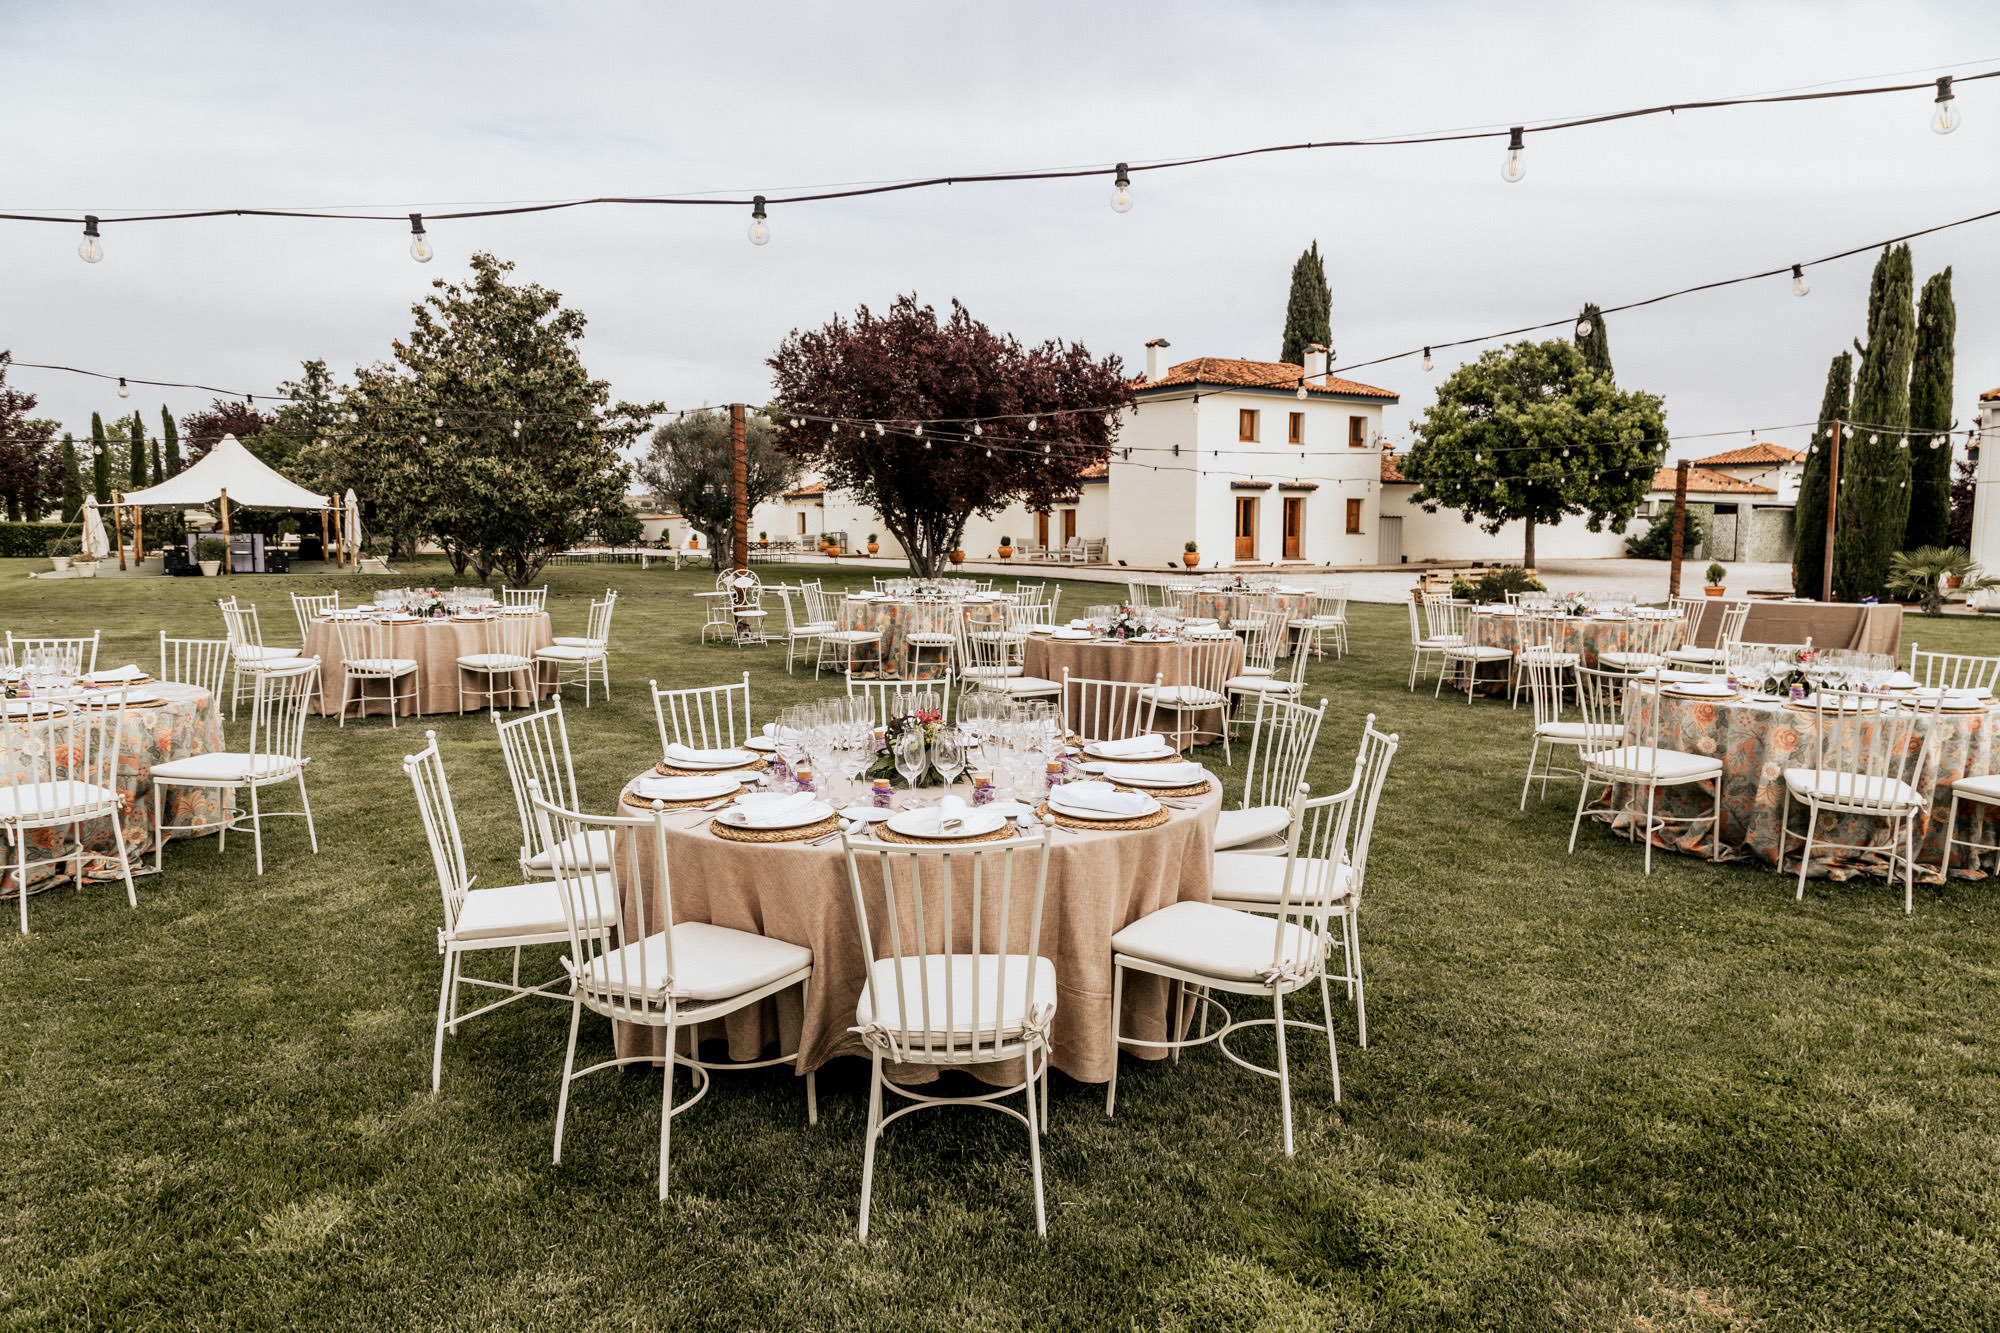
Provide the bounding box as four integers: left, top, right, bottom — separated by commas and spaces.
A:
150, 656, 320, 875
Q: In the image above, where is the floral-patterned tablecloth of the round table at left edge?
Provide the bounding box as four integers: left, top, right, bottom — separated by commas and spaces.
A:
0, 683, 222, 897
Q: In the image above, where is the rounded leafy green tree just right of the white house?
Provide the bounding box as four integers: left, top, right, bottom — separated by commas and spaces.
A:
1402, 338, 1666, 566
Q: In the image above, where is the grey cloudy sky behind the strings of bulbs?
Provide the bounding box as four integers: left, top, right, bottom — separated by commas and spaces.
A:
0, 0, 2000, 454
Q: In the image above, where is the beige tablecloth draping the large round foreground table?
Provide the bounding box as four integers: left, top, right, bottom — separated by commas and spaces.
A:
616, 779, 1222, 1083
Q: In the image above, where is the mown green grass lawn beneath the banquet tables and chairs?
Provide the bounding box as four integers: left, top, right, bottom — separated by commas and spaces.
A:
0, 560, 2000, 1329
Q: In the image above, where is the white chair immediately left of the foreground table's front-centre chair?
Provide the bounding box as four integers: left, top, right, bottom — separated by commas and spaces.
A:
530, 789, 820, 1199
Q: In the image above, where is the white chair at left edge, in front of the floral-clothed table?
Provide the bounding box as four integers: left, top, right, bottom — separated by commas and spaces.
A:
0, 691, 138, 935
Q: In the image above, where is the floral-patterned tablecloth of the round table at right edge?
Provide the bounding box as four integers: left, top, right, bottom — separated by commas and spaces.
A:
1594, 689, 1994, 881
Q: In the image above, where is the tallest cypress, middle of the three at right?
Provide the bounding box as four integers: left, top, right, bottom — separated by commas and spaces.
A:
1834, 244, 1916, 602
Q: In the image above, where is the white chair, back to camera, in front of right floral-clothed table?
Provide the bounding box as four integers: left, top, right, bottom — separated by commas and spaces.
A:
1776, 689, 1950, 913
